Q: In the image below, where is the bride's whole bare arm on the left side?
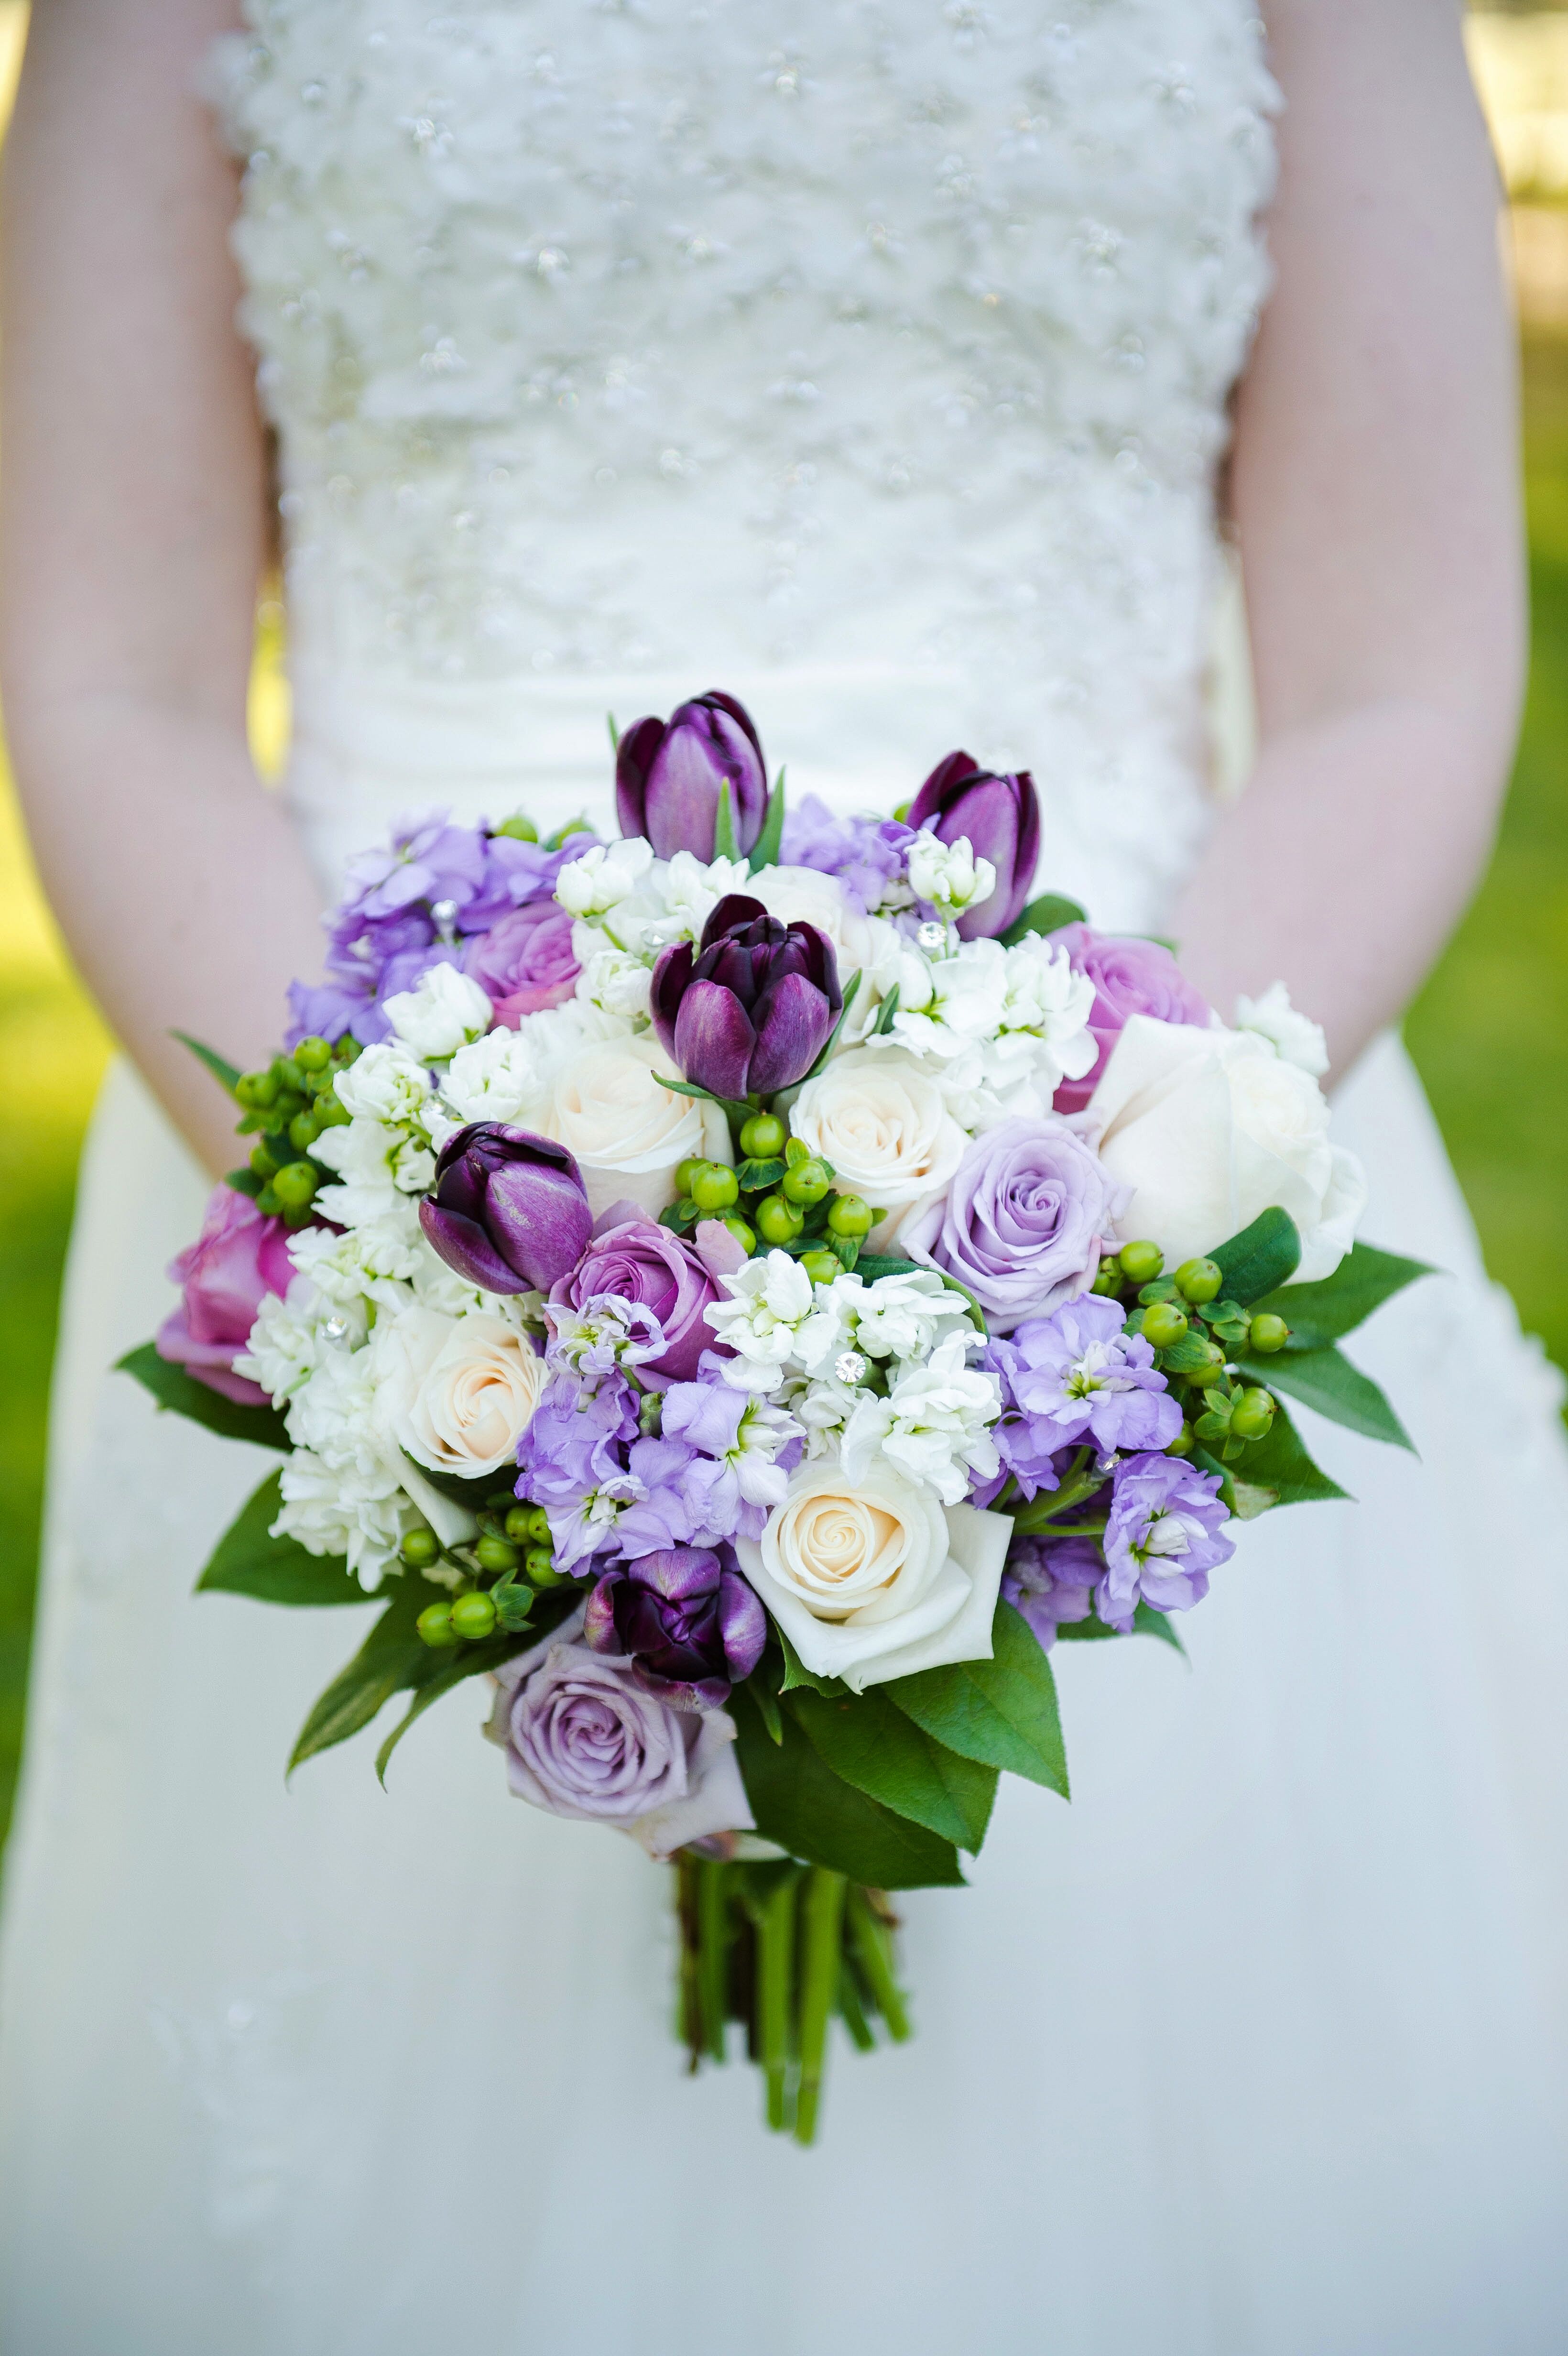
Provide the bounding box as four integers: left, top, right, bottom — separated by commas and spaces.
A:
0, 0, 320, 1168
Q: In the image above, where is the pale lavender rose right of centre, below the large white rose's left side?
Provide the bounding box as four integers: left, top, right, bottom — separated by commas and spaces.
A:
899, 1114, 1123, 1333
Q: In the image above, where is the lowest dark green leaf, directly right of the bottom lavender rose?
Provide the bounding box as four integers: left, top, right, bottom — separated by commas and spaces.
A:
730, 1685, 963, 1889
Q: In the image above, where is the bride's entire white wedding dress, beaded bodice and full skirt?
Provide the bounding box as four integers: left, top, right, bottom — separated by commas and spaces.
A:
0, 0, 1568, 2356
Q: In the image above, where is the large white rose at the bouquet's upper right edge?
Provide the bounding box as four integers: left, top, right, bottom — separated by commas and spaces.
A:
1088, 1015, 1365, 1284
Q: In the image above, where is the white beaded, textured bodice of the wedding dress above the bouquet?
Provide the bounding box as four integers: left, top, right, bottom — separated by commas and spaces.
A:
219, 0, 1274, 918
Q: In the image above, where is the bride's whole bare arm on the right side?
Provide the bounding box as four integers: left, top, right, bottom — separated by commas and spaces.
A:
1177, 0, 1523, 1069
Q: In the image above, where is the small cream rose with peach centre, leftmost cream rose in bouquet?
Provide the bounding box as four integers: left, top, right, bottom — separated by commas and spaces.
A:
374, 1308, 544, 1480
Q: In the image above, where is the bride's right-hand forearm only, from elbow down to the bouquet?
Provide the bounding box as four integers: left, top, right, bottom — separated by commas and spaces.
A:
1175, 700, 1507, 1074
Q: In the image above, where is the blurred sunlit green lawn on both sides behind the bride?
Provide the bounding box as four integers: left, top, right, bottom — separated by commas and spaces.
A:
0, 339, 1568, 1831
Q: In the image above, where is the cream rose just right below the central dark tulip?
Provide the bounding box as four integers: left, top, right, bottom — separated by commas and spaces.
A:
789, 1046, 970, 1251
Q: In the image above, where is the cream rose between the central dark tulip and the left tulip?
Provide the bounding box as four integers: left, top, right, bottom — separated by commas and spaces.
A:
537, 1032, 735, 1218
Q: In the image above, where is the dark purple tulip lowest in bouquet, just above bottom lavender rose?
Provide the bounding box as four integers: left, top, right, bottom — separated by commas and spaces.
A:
581, 1546, 768, 1711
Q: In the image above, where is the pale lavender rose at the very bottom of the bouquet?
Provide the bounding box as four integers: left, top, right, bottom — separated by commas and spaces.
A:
490, 1642, 753, 1856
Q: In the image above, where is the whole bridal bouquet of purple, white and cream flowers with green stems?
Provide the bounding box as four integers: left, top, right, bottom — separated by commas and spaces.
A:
125, 695, 1422, 2142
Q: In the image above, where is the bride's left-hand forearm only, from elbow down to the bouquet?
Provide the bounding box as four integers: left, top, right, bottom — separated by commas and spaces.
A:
7, 695, 320, 1171
